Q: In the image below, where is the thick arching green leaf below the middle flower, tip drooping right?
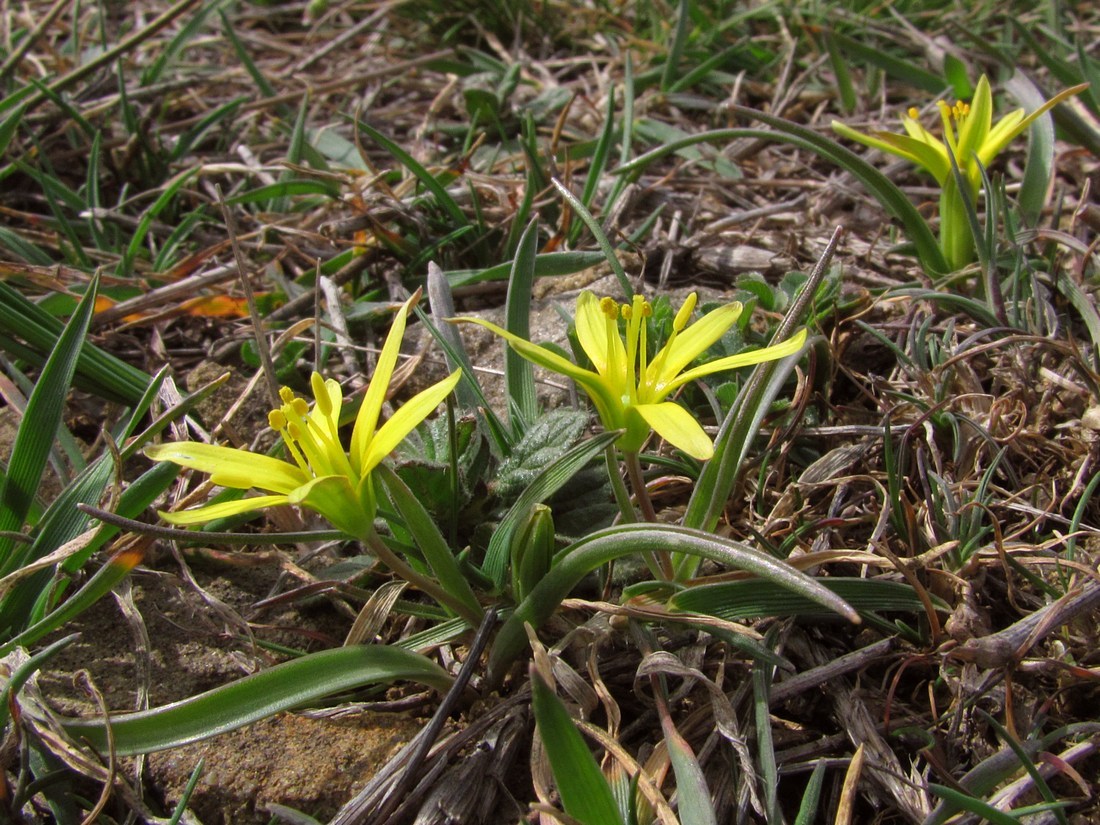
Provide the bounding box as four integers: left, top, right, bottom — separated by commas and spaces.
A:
488, 524, 859, 681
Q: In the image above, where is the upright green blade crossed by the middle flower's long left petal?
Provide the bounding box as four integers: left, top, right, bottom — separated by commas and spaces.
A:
504, 218, 539, 436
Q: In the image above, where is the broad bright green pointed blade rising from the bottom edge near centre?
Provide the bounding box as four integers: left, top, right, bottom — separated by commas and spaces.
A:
531, 668, 623, 825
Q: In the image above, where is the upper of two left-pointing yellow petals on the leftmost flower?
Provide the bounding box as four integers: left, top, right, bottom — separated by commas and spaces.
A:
145, 441, 309, 493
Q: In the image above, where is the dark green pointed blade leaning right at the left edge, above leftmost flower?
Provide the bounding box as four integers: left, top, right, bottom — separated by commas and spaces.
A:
0, 279, 98, 575
